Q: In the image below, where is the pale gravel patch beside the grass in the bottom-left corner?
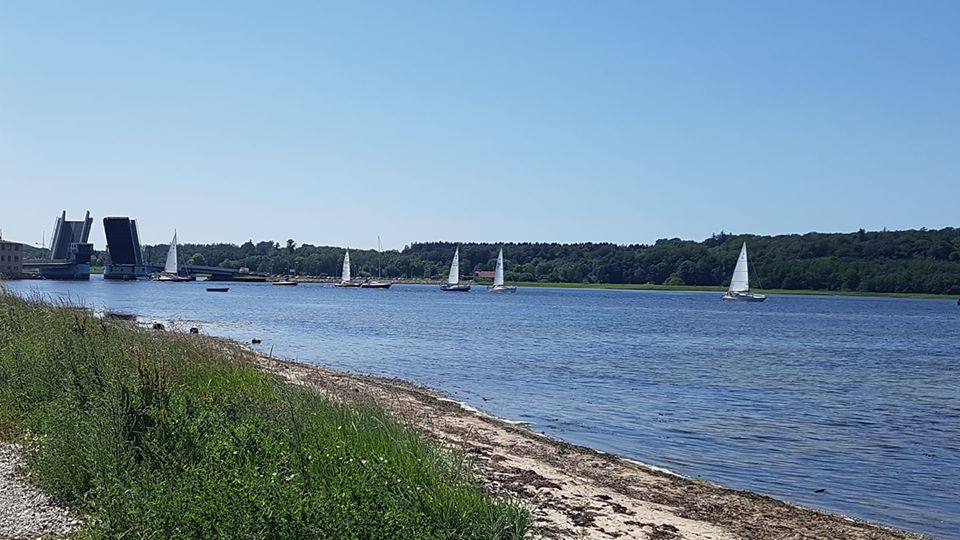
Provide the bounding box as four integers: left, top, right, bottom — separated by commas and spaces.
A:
0, 442, 79, 540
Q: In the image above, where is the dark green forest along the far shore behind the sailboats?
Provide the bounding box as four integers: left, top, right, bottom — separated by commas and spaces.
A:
92, 228, 960, 294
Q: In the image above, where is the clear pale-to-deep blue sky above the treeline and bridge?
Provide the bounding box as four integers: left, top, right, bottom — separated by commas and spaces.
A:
0, 0, 960, 248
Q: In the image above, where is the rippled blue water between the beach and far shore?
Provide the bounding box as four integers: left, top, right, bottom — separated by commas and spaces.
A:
7, 278, 960, 538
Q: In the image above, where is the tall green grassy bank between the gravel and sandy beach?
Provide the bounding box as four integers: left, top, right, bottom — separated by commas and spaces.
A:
0, 293, 528, 538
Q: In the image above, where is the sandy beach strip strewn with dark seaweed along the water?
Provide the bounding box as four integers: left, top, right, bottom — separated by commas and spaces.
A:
236, 342, 922, 540
